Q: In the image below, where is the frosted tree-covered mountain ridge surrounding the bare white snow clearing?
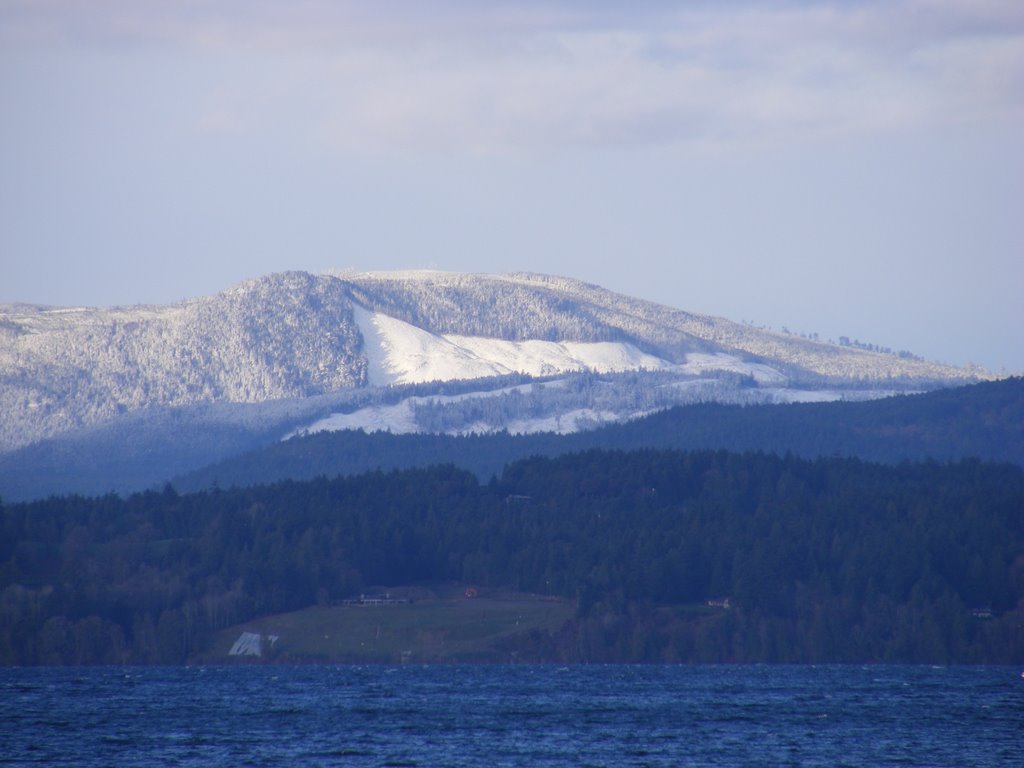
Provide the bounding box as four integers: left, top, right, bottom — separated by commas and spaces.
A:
0, 271, 980, 450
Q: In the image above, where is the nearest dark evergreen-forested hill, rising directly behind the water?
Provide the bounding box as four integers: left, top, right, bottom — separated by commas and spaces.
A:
0, 451, 1024, 664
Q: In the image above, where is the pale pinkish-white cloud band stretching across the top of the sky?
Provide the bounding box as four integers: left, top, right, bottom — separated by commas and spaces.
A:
0, 0, 1024, 153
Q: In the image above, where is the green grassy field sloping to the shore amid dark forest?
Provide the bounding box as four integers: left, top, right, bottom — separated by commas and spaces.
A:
195, 585, 574, 664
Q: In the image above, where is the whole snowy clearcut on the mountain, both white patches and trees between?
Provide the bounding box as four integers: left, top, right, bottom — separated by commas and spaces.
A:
285, 305, 921, 439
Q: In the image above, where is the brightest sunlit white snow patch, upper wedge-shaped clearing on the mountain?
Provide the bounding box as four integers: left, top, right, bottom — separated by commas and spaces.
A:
353, 306, 671, 386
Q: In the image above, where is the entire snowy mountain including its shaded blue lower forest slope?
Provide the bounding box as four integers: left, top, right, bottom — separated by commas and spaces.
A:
0, 271, 1001, 501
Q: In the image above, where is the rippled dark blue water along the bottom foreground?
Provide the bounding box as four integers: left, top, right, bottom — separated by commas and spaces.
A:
0, 667, 1024, 768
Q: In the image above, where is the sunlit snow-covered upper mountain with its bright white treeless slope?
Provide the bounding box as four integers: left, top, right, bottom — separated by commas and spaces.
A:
0, 271, 979, 451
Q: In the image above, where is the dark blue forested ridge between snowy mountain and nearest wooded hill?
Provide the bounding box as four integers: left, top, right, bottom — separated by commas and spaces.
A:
174, 378, 1024, 490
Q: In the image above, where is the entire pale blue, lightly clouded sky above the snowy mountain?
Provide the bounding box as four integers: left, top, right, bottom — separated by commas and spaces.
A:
0, 0, 1024, 373
